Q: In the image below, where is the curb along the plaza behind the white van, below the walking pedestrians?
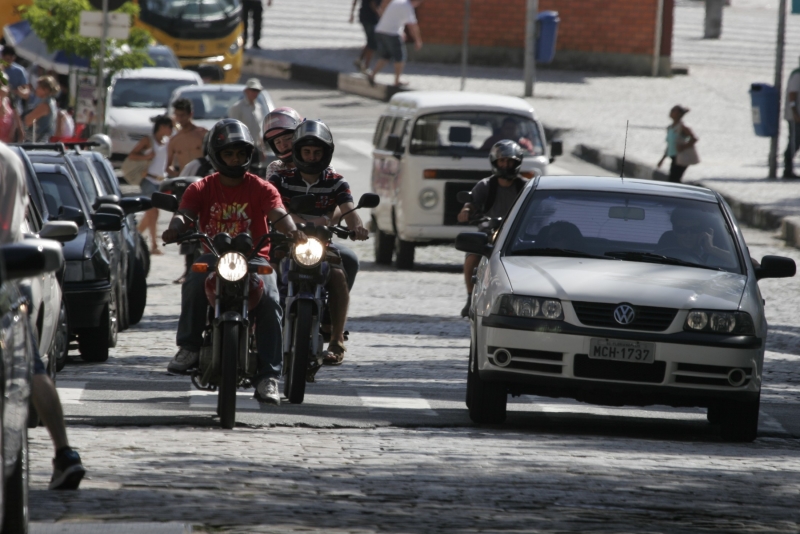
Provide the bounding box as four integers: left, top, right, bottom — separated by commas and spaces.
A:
242, 54, 408, 102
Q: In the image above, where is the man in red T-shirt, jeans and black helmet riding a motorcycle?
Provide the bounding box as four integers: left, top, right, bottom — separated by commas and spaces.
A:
162, 119, 305, 404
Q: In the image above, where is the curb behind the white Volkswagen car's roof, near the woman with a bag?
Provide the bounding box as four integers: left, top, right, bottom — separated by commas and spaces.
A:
572, 144, 800, 248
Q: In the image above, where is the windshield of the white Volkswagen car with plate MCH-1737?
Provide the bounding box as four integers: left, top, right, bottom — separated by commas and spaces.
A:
506, 190, 743, 273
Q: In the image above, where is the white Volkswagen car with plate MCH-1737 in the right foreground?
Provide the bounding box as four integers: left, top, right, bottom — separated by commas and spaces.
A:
456, 176, 795, 441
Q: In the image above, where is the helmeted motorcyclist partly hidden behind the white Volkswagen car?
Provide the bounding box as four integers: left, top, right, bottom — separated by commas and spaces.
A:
458, 139, 527, 317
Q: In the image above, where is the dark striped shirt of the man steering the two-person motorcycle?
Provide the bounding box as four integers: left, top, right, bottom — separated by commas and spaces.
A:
269, 167, 353, 217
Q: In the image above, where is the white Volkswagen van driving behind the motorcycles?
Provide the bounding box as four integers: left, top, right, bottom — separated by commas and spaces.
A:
372, 91, 562, 269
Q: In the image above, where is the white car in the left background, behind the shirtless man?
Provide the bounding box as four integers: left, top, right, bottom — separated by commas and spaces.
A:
106, 67, 203, 159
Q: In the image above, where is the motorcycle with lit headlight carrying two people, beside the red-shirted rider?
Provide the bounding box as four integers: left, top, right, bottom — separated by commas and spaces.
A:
275, 193, 380, 404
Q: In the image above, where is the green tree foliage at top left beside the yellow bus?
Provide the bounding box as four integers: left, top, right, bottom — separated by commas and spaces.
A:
19, 0, 153, 74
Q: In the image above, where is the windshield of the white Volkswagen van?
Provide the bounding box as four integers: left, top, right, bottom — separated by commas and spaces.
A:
410, 112, 544, 159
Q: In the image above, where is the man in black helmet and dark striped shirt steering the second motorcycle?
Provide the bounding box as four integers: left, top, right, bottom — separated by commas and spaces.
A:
269, 120, 369, 365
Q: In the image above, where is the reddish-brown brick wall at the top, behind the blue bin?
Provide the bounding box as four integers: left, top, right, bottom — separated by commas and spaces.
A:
417, 0, 674, 74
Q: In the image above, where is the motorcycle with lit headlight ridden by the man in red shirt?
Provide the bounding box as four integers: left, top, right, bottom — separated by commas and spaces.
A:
153, 193, 291, 429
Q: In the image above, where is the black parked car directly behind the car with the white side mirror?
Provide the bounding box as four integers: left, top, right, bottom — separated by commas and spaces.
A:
33, 161, 123, 362
